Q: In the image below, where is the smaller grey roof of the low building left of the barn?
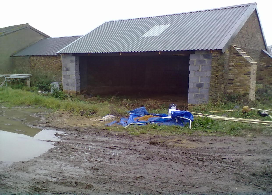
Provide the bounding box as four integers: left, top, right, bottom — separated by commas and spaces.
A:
13, 36, 80, 56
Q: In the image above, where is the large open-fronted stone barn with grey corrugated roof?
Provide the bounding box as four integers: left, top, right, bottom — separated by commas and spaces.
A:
58, 3, 272, 104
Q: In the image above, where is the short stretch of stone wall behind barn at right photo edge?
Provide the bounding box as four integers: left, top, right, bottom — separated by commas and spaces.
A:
257, 51, 272, 86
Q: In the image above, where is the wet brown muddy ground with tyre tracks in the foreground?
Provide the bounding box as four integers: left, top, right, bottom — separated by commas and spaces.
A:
0, 110, 272, 194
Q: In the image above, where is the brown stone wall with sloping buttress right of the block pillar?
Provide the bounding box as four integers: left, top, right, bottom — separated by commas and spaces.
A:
209, 46, 257, 102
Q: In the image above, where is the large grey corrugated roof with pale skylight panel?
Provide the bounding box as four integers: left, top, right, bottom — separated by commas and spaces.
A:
58, 3, 257, 53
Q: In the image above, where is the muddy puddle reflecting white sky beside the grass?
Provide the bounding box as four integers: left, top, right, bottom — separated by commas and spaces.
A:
0, 107, 60, 163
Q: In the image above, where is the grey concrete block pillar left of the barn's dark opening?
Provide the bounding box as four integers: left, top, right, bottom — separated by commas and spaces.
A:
61, 55, 80, 93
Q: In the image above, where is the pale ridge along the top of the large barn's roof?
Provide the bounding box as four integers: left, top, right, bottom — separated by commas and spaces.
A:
105, 2, 257, 23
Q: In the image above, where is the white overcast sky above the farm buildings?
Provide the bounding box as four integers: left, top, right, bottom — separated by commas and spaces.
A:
0, 0, 272, 45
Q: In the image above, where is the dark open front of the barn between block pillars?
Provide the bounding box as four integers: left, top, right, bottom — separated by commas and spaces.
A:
79, 54, 189, 103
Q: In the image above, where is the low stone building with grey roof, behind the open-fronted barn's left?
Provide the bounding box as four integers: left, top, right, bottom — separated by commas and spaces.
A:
11, 36, 80, 82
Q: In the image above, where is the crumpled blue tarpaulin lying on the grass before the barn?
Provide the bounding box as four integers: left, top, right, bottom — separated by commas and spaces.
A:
108, 107, 194, 128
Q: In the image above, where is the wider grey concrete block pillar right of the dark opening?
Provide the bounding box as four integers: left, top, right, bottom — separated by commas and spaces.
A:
188, 52, 212, 104
